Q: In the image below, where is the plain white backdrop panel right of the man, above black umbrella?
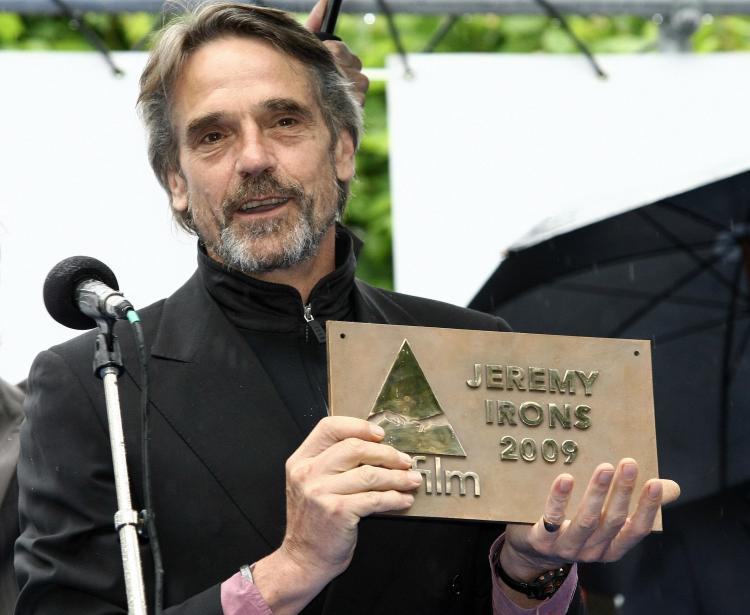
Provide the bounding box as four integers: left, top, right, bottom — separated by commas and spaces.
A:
388, 54, 750, 305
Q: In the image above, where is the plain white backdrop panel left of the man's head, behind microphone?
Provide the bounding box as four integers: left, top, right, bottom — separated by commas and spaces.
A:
0, 52, 195, 382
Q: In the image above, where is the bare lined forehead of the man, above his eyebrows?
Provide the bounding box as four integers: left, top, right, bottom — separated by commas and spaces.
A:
172, 36, 318, 126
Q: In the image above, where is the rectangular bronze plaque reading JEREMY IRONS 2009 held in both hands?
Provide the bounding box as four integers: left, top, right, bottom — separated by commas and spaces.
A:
327, 322, 661, 530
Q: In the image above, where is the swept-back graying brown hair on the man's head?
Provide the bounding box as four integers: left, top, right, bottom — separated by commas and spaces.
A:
138, 2, 363, 231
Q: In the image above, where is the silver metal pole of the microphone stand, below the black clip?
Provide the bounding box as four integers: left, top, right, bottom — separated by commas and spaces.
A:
100, 367, 147, 615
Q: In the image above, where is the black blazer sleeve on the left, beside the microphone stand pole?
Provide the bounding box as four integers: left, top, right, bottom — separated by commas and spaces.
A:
15, 351, 222, 615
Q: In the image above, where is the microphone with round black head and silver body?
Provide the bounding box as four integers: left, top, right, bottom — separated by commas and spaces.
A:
44, 256, 133, 329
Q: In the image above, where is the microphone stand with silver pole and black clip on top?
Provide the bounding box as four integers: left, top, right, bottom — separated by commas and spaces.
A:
94, 318, 147, 615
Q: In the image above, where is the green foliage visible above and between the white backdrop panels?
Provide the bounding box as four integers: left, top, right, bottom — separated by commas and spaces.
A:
0, 13, 750, 287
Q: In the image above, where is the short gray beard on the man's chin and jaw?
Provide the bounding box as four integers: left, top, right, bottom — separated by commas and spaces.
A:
210, 203, 336, 275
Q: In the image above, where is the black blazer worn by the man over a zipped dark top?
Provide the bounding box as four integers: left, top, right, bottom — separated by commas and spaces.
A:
16, 274, 507, 615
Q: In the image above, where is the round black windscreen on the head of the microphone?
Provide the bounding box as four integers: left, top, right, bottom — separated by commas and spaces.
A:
44, 256, 120, 329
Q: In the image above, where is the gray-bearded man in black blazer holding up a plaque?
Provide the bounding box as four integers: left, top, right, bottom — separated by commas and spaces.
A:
16, 4, 676, 615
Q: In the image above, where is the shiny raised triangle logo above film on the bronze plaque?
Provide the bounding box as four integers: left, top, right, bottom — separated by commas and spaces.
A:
368, 340, 466, 457
